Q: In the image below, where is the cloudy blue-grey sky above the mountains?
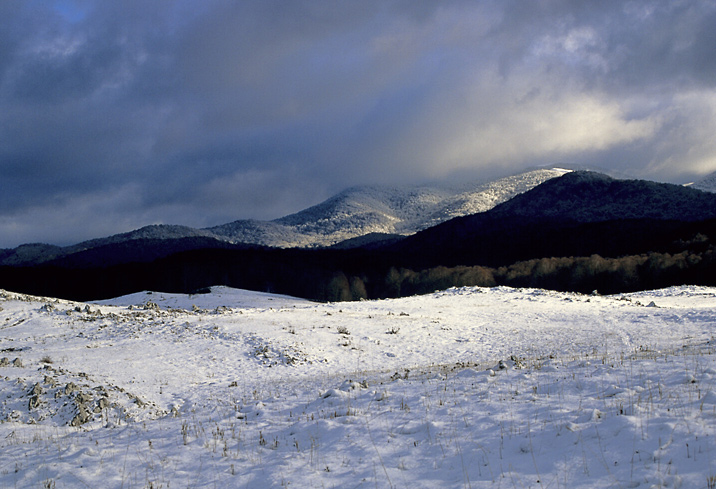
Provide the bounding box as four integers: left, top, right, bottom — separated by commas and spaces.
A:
0, 0, 716, 248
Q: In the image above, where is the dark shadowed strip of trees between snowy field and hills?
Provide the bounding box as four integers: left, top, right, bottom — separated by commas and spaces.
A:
0, 228, 716, 301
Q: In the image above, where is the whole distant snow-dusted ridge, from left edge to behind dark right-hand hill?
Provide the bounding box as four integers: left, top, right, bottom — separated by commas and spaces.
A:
0, 168, 570, 266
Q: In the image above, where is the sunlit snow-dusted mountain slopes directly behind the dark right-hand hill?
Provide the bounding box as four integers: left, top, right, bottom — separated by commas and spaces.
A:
207, 169, 569, 247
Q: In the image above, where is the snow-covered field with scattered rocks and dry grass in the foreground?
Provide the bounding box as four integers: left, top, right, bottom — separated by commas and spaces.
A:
0, 287, 716, 489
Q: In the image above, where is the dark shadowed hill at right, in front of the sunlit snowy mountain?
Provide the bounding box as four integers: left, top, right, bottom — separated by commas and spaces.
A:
392, 172, 716, 266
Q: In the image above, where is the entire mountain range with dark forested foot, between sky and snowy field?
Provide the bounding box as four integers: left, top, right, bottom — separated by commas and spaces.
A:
0, 169, 716, 300
